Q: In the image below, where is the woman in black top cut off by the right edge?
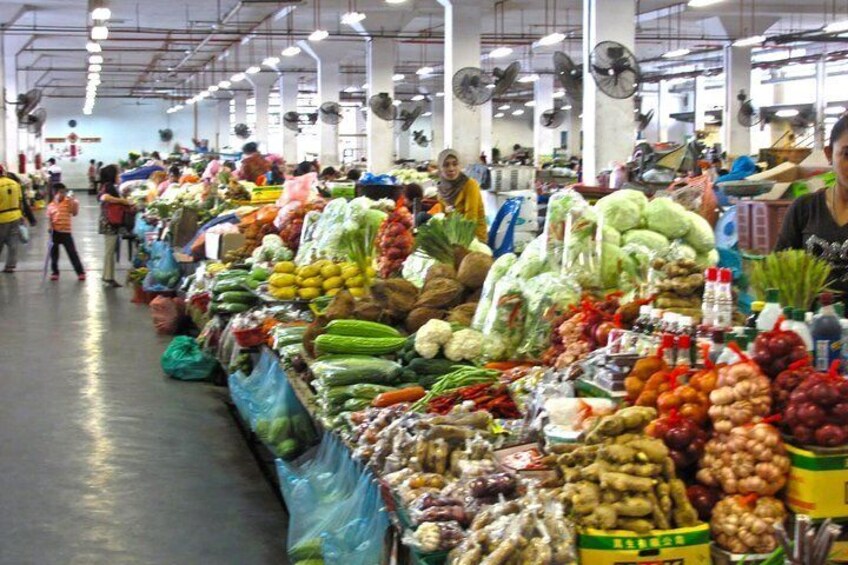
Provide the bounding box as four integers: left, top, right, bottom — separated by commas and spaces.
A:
775, 115, 848, 300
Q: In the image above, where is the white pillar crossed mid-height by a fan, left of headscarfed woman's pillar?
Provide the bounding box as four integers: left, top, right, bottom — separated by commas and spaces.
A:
366, 38, 398, 174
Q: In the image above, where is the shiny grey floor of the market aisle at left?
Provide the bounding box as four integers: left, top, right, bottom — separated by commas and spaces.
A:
0, 195, 286, 565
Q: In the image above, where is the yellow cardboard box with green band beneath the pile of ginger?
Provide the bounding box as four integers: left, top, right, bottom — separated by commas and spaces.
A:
577, 524, 711, 565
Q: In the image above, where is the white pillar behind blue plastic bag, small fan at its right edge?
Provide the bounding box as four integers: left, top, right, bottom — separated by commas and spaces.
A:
722, 46, 751, 157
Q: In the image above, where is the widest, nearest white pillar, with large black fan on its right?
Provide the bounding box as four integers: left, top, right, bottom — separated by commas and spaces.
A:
583, 0, 636, 186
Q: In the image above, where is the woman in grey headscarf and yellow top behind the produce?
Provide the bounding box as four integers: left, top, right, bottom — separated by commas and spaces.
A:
430, 149, 488, 241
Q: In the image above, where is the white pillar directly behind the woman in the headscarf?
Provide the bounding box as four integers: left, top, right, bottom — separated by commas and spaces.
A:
439, 0, 483, 165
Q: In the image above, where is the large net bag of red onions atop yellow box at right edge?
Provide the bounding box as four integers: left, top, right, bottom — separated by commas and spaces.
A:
783, 372, 848, 447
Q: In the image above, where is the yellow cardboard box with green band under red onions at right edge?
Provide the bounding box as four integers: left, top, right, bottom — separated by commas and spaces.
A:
786, 445, 848, 518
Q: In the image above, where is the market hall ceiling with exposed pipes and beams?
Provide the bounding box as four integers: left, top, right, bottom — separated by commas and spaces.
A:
0, 0, 848, 103
